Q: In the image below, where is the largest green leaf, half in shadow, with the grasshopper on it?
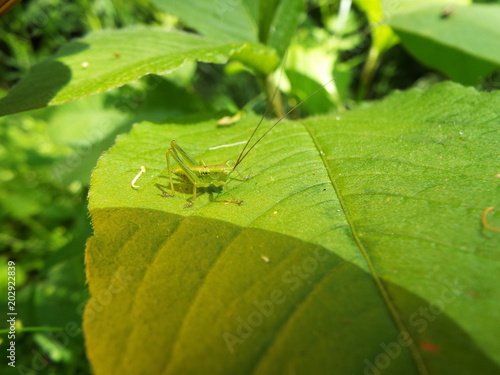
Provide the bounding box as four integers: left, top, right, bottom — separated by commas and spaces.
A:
84, 84, 500, 374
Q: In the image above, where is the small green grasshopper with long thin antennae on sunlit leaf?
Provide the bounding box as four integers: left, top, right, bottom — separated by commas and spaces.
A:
162, 80, 333, 207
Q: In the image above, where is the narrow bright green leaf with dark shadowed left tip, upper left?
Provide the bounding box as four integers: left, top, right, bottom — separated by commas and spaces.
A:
0, 28, 278, 115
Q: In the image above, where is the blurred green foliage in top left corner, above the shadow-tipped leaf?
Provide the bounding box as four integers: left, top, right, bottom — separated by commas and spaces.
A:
0, 0, 162, 89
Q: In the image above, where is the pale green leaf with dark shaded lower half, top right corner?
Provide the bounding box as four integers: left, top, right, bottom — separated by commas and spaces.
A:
390, 4, 500, 85
